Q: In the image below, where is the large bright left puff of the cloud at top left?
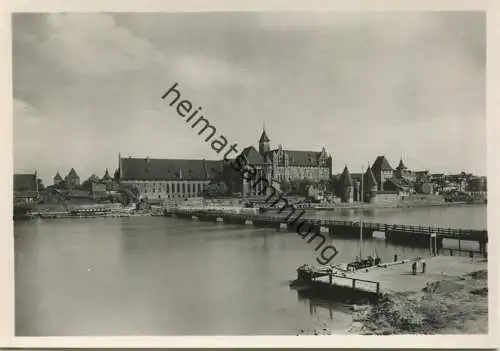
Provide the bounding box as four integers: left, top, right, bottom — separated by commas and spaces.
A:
40, 14, 162, 75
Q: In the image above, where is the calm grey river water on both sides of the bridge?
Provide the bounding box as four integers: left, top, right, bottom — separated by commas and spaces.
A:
14, 206, 486, 336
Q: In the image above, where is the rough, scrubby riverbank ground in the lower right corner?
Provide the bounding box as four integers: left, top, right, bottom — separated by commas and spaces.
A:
300, 261, 488, 335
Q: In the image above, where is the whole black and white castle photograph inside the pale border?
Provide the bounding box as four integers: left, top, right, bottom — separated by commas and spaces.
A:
2, 2, 498, 348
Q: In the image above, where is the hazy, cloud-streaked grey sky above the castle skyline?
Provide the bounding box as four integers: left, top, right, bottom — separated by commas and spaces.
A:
12, 12, 486, 185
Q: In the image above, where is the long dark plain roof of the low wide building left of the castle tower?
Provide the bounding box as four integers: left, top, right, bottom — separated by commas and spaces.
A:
120, 158, 223, 180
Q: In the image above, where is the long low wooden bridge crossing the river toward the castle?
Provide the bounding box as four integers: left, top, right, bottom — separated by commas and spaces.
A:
164, 209, 488, 256
